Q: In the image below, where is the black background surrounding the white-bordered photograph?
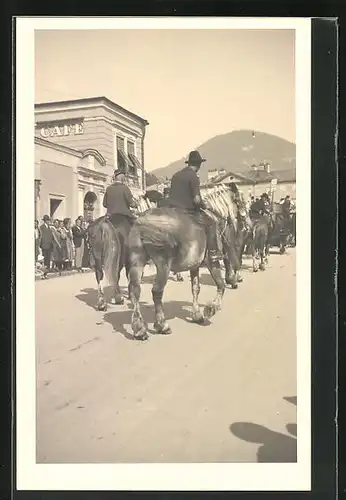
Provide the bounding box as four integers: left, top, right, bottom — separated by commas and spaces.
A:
0, 6, 340, 500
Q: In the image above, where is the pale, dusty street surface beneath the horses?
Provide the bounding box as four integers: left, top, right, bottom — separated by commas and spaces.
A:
35, 249, 297, 463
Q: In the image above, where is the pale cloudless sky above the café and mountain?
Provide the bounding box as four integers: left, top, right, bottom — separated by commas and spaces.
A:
35, 29, 295, 171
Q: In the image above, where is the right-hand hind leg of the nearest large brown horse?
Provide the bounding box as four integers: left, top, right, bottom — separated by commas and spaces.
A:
151, 256, 172, 335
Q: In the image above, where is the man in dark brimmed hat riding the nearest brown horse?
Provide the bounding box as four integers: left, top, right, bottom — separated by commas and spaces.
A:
170, 151, 223, 262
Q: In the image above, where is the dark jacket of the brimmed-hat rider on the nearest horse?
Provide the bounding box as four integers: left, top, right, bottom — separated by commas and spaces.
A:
169, 167, 201, 210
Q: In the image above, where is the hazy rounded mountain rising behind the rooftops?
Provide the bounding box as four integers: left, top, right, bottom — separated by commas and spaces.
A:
151, 130, 296, 182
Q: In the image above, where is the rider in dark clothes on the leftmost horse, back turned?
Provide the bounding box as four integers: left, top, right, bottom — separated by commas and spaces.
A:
103, 170, 136, 234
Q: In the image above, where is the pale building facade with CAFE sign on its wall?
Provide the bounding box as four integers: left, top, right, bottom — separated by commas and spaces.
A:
35, 97, 148, 219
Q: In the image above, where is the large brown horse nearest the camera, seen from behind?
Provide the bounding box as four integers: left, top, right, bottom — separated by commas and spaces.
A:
116, 208, 225, 340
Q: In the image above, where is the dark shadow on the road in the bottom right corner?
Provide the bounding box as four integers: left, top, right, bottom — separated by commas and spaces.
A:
230, 422, 297, 463
